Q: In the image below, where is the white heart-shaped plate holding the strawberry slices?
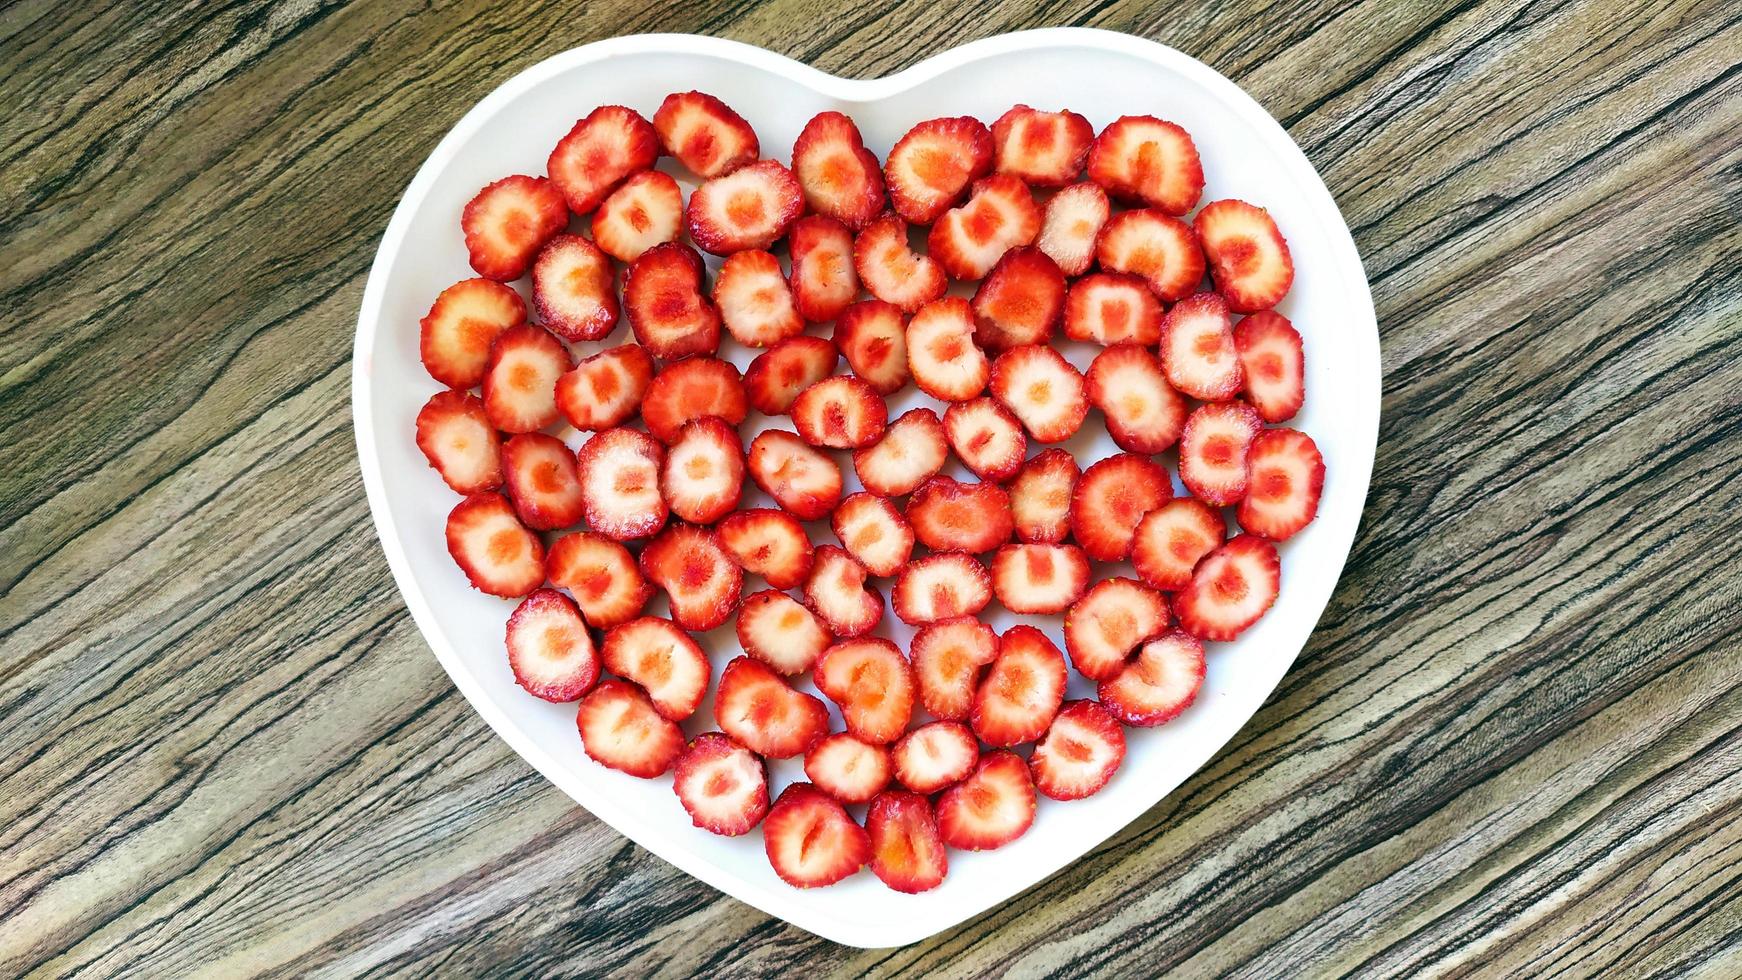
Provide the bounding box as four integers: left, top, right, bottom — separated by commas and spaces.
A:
352, 30, 1380, 947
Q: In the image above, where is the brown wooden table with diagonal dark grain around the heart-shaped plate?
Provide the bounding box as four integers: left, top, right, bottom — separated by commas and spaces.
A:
0, 0, 1742, 977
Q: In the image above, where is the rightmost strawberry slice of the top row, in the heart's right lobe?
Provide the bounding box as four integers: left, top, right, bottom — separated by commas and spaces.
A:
1089, 115, 1204, 214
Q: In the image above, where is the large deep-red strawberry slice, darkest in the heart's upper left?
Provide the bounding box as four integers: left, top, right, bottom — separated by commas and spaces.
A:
624, 242, 719, 360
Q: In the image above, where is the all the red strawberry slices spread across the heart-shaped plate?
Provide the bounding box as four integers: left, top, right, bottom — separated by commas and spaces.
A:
416, 92, 1324, 891
